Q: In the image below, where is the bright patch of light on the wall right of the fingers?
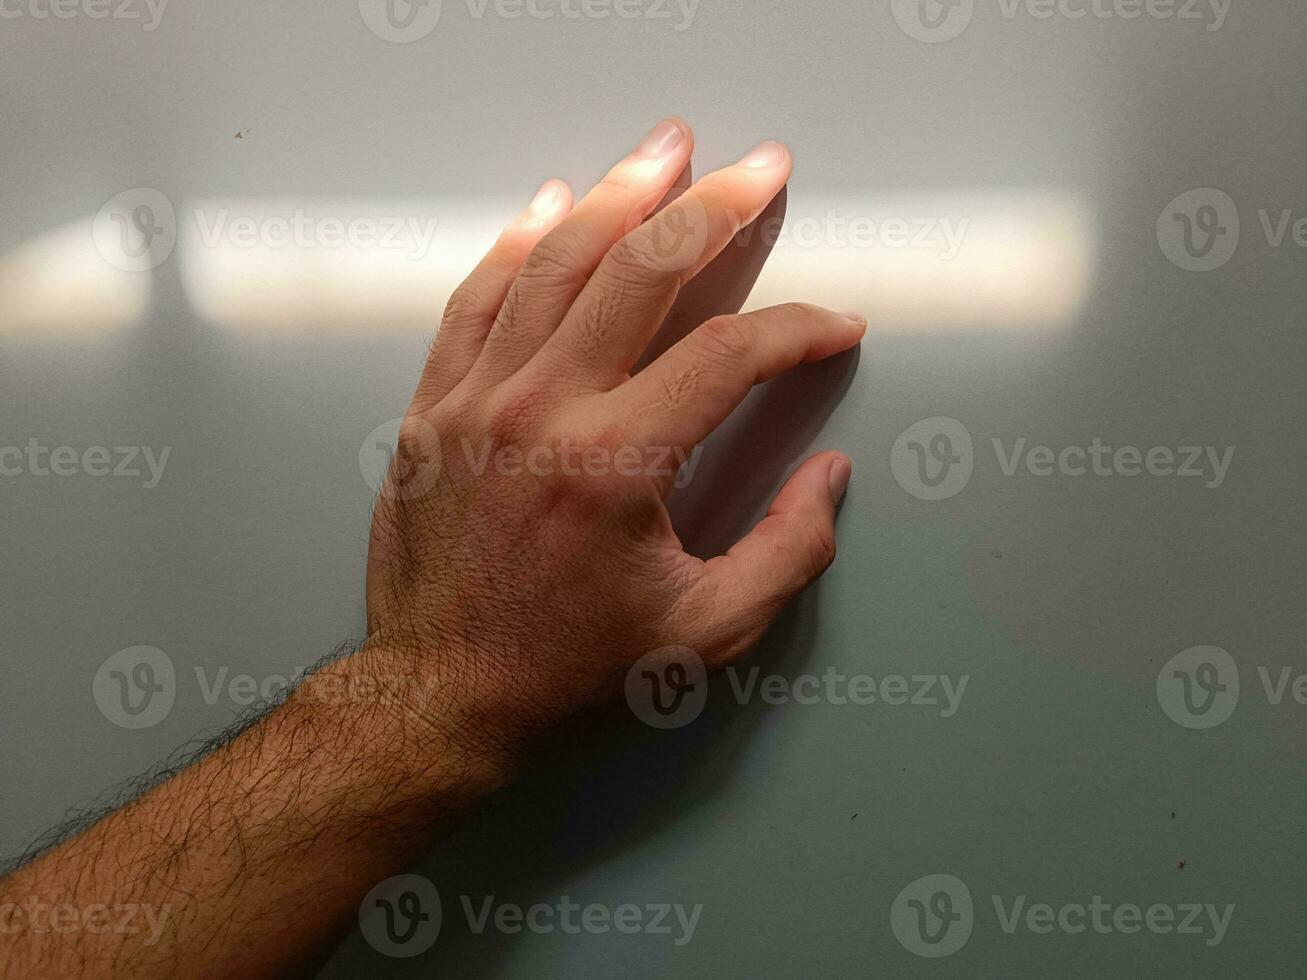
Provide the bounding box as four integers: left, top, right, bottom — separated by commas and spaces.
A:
748, 192, 1097, 333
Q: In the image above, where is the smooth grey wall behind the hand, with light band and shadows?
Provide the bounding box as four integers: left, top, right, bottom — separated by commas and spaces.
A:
0, 0, 1307, 980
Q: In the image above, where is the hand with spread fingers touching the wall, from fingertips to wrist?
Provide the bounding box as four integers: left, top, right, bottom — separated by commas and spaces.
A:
367, 120, 865, 754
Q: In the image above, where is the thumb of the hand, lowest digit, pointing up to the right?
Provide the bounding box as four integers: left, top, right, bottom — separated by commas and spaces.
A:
690, 452, 853, 661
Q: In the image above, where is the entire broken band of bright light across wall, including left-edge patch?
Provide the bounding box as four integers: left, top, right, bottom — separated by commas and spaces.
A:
0, 191, 1097, 335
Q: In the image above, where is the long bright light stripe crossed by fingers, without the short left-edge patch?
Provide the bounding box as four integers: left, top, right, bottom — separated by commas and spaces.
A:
179, 191, 1097, 333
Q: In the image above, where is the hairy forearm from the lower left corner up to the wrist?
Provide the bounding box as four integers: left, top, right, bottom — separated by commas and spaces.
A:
0, 644, 507, 977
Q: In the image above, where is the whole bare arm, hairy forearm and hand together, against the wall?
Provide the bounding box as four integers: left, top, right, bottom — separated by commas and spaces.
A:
0, 120, 865, 977
